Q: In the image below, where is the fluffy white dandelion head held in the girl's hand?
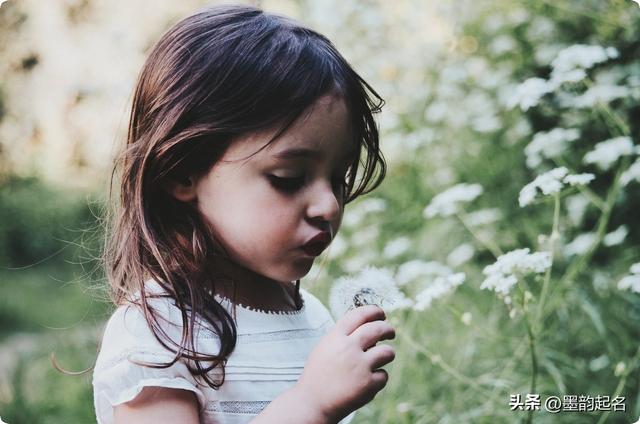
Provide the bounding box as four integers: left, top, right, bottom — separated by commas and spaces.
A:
329, 266, 411, 319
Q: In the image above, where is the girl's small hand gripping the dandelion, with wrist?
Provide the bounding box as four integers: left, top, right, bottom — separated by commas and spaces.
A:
294, 305, 396, 422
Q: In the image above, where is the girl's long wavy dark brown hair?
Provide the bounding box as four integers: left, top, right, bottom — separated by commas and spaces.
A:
103, 5, 386, 388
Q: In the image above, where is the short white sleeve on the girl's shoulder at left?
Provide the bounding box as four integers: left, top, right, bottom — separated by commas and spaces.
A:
93, 305, 212, 424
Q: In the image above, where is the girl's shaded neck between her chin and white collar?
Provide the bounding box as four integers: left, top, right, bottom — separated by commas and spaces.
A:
213, 256, 302, 312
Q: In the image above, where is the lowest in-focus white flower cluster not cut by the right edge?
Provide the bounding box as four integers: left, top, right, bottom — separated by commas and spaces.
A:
480, 248, 551, 295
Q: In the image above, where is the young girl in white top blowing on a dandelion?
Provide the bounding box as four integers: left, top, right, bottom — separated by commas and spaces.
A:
93, 6, 395, 424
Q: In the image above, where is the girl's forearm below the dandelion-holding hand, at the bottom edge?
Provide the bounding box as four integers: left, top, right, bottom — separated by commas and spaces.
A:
251, 386, 338, 424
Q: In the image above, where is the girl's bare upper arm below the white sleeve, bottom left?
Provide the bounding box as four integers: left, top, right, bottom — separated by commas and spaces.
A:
114, 387, 200, 424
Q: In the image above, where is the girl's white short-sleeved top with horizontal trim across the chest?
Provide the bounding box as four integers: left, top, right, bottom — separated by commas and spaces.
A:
93, 281, 355, 424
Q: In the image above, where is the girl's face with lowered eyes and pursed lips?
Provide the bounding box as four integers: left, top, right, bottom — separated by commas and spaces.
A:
194, 95, 355, 282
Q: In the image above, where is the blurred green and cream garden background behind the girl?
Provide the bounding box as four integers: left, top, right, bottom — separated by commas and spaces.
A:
0, 0, 640, 424
